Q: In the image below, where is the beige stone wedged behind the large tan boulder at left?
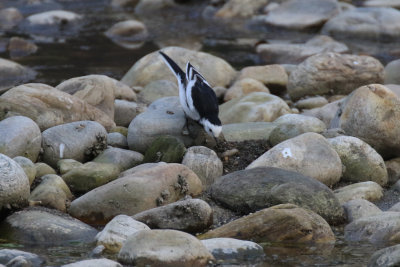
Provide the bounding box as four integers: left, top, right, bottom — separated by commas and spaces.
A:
56, 75, 117, 119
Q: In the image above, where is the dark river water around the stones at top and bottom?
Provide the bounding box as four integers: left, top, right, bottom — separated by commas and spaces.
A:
0, 0, 400, 266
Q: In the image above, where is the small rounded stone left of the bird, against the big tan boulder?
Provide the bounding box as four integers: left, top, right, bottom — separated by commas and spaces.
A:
138, 80, 179, 104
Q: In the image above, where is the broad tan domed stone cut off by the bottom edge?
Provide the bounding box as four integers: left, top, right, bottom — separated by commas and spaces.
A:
118, 230, 214, 267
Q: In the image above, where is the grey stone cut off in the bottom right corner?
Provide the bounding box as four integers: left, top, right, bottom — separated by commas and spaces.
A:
368, 245, 400, 267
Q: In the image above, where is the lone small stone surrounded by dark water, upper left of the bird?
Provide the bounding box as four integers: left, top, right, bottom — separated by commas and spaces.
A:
104, 19, 149, 49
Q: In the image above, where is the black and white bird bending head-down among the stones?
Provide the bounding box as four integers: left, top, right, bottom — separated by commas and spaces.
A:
159, 51, 222, 138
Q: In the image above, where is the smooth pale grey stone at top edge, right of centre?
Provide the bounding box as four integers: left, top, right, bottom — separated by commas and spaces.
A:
265, 0, 339, 30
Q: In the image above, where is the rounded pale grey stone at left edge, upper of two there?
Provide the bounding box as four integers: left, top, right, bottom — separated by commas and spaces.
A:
0, 116, 42, 161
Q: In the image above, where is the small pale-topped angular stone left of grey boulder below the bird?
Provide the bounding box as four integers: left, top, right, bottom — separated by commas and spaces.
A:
114, 99, 146, 127
